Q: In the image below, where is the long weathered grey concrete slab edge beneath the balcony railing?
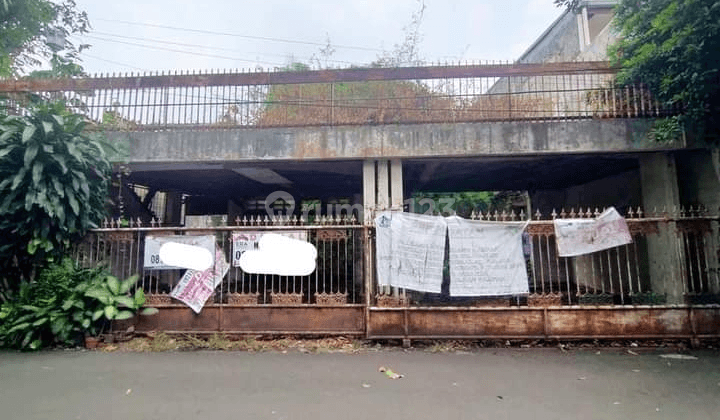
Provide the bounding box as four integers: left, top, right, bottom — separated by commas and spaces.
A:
108, 119, 672, 163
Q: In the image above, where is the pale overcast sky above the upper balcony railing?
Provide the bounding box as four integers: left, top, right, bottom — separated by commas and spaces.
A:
73, 0, 562, 74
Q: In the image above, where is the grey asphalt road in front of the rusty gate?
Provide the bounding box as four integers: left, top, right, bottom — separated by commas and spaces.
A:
0, 349, 720, 420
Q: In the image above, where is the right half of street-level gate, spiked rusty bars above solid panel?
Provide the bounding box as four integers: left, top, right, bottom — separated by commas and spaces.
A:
373, 208, 720, 307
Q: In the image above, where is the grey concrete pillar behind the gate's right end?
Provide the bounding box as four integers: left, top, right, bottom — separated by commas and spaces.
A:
640, 152, 686, 304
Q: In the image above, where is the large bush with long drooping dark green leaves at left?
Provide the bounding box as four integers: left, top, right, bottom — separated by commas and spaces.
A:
0, 103, 111, 291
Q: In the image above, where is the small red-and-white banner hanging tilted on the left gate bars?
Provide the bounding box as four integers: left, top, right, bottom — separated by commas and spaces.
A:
170, 249, 230, 314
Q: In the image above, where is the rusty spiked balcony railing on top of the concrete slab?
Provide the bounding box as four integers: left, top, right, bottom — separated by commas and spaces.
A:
0, 62, 680, 131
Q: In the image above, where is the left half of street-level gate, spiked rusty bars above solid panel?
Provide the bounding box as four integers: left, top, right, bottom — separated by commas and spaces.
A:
75, 218, 367, 305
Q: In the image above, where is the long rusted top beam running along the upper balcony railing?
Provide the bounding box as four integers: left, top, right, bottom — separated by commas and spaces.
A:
0, 61, 617, 92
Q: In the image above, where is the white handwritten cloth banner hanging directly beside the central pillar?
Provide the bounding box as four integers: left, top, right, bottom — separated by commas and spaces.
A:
375, 212, 447, 293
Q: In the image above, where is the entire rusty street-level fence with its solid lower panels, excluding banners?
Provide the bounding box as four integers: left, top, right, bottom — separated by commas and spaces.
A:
76, 209, 720, 340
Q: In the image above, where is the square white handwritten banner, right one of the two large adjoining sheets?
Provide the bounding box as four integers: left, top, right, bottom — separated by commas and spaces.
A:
447, 216, 529, 296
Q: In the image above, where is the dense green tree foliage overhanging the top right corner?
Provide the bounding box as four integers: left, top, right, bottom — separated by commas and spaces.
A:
555, 0, 720, 145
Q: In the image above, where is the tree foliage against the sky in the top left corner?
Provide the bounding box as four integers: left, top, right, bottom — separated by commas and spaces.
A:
0, 0, 90, 77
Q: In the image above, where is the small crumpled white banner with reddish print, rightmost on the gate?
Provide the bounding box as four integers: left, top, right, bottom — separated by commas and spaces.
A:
555, 207, 632, 257
